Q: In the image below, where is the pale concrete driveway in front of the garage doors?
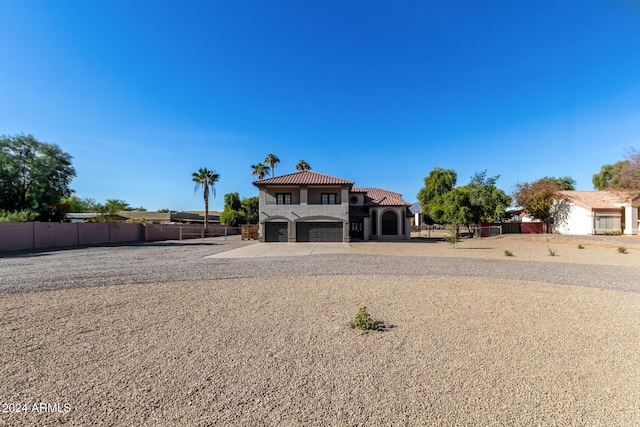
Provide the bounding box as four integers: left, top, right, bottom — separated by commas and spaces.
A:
205, 243, 350, 258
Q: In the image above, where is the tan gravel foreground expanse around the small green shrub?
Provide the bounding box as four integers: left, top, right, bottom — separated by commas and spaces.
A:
0, 276, 640, 426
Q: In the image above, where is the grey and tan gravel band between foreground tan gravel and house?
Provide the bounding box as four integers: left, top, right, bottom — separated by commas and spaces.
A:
0, 236, 640, 293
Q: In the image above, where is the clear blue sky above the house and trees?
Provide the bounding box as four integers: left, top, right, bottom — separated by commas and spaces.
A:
0, 0, 640, 210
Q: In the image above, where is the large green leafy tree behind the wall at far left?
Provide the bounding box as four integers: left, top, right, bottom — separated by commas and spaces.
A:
0, 135, 76, 221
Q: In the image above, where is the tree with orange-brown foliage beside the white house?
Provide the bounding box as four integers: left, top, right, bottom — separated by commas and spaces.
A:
513, 177, 575, 232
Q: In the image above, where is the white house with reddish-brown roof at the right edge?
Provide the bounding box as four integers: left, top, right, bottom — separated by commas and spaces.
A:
553, 191, 640, 234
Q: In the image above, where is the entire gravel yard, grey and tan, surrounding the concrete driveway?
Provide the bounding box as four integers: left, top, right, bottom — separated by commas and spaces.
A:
0, 236, 640, 426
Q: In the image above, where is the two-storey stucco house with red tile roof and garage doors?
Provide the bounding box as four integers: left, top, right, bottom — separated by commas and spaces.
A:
253, 171, 411, 242
